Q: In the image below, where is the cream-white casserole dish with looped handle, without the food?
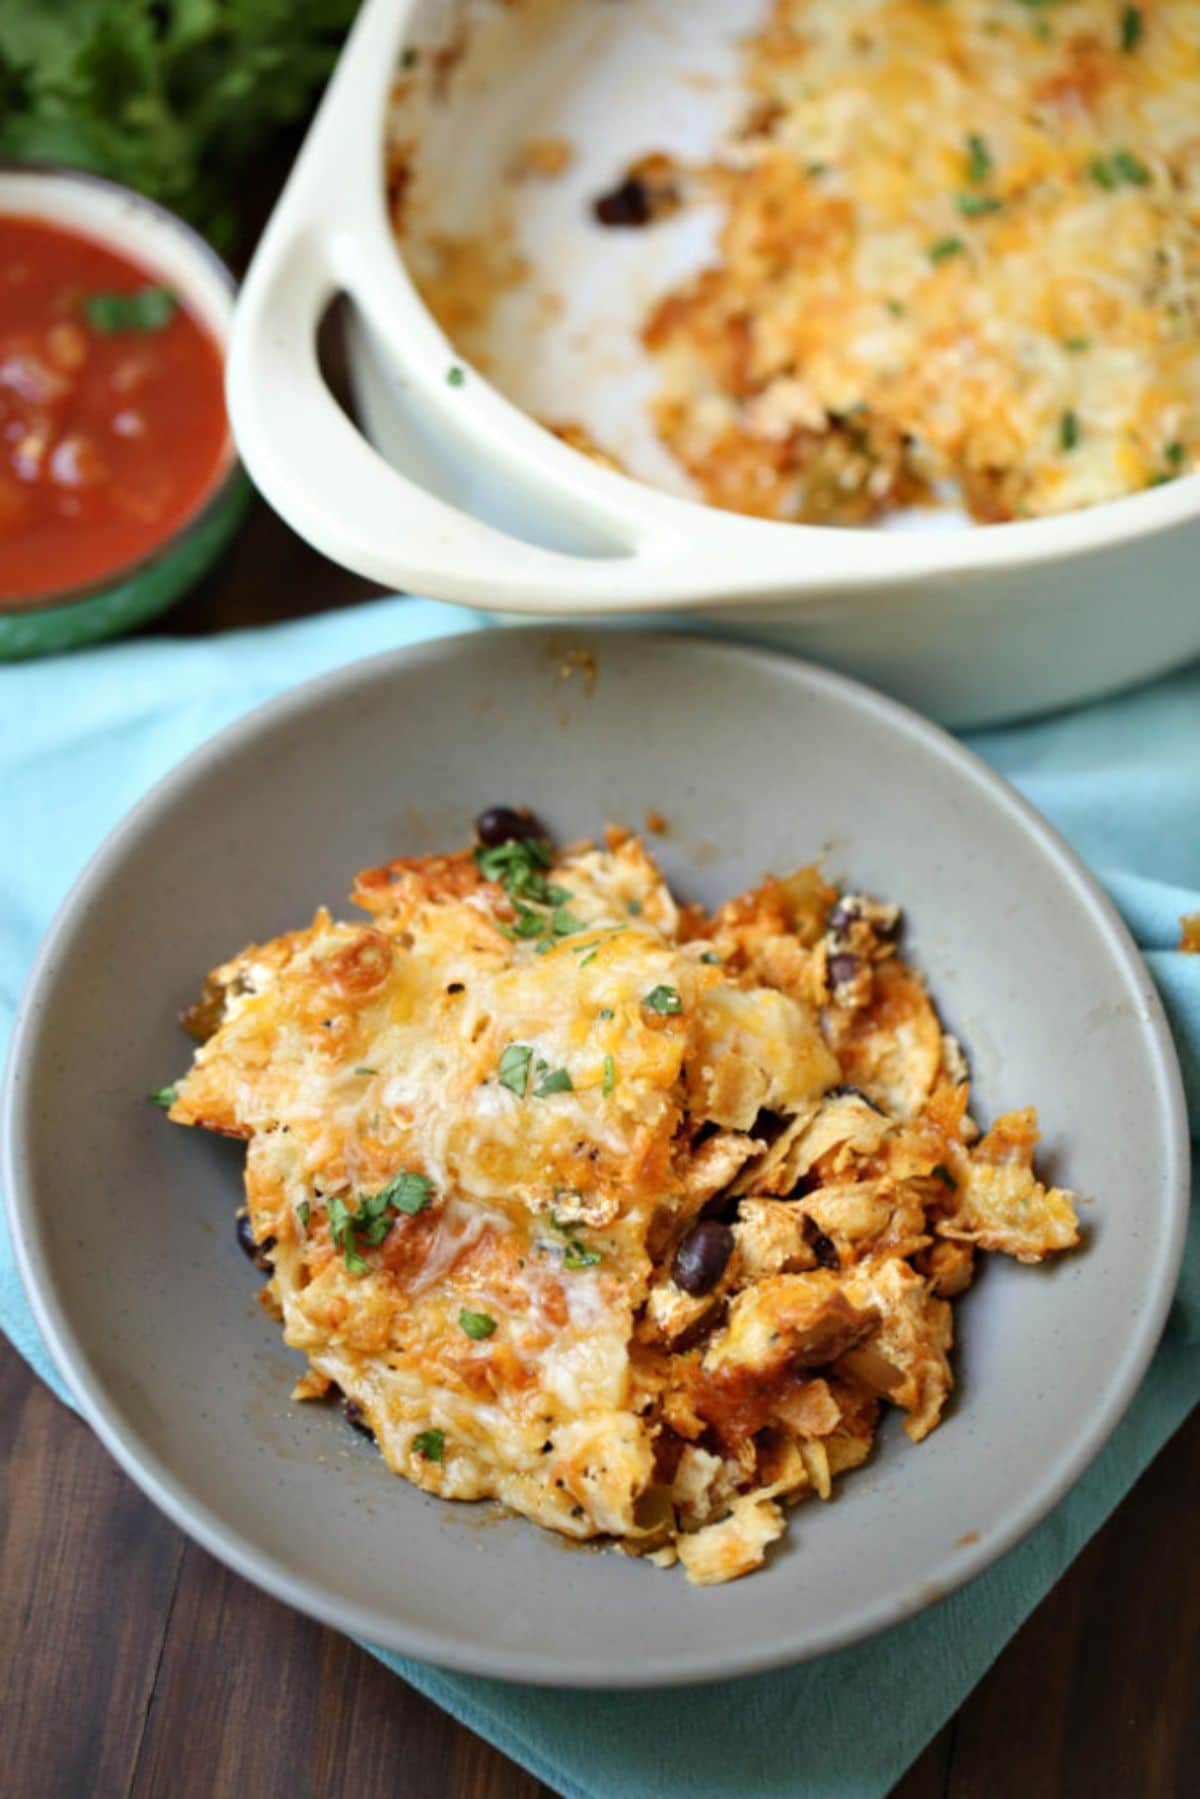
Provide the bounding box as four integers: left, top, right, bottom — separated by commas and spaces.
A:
228, 0, 1200, 725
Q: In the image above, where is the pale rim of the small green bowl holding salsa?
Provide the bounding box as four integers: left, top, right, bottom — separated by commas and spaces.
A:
0, 157, 246, 628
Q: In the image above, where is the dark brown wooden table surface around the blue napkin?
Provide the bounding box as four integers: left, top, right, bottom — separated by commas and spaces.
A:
0, 435, 1200, 1799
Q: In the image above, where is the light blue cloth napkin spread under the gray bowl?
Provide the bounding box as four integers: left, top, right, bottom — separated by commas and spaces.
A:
0, 599, 1200, 1799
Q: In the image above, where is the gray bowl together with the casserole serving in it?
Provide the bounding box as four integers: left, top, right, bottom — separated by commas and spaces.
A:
0, 630, 1187, 1686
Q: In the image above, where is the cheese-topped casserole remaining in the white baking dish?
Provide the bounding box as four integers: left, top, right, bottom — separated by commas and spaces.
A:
646, 0, 1200, 522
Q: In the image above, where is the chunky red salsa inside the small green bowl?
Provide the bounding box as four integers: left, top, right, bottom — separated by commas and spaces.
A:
0, 216, 228, 604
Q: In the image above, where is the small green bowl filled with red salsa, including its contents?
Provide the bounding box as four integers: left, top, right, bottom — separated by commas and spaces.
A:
0, 166, 248, 658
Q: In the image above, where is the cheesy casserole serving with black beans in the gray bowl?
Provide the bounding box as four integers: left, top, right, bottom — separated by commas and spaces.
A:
171, 833, 1078, 1583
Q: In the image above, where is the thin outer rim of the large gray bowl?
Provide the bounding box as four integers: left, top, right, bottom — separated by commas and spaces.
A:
0, 624, 1189, 1689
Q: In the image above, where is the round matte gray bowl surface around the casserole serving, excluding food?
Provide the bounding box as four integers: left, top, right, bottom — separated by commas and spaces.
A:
4, 630, 1187, 1686
